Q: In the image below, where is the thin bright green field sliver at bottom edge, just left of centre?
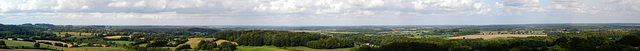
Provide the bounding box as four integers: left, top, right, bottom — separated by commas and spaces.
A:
287, 46, 351, 51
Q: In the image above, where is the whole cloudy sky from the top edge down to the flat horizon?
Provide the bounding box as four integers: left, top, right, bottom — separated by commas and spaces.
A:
0, 0, 640, 26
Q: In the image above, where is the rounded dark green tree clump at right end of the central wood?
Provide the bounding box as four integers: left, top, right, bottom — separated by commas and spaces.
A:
306, 38, 354, 49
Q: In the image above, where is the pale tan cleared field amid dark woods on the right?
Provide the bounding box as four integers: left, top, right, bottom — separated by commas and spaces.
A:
449, 34, 547, 39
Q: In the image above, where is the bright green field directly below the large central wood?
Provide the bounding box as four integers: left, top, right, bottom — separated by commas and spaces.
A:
236, 46, 292, 51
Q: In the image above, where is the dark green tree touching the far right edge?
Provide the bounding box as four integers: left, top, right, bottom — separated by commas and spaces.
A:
617, 35, 640, 46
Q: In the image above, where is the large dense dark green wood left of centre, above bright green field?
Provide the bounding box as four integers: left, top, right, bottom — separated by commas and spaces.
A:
214, 30, 330, 47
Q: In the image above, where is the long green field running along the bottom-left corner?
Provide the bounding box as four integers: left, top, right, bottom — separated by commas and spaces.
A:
2, 39, 127, 51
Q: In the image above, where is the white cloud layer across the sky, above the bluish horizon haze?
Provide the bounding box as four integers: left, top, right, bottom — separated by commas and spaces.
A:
0, 0, 640, 24
